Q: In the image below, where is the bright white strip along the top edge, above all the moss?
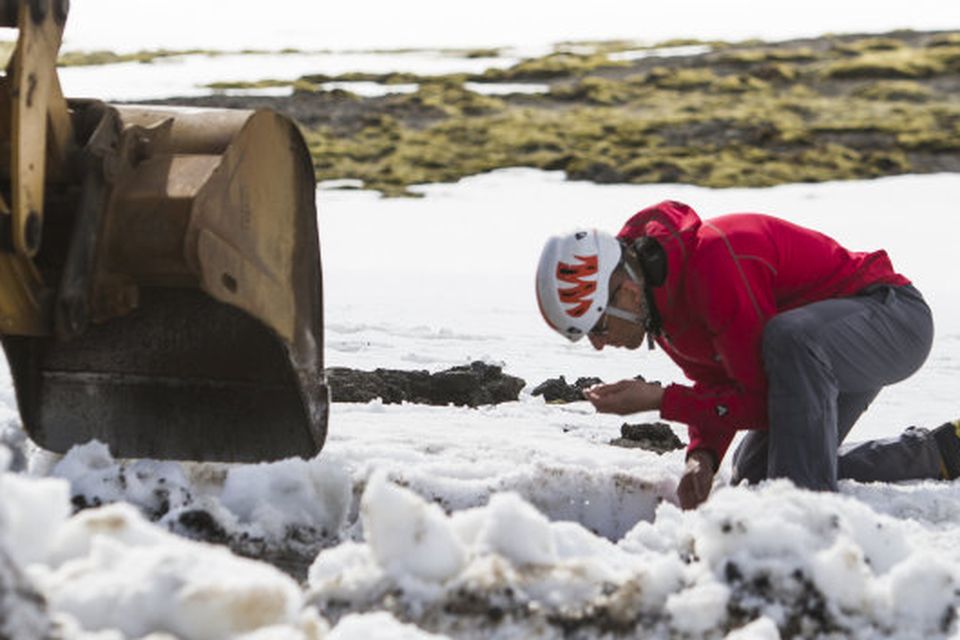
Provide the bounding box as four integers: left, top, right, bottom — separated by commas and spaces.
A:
65, 0, 960, 50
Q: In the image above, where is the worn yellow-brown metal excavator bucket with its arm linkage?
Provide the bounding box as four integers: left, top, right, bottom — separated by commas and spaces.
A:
0, 0, 329, 462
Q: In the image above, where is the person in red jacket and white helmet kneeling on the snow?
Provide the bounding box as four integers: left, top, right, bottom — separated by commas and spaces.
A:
537, 201, 960, 508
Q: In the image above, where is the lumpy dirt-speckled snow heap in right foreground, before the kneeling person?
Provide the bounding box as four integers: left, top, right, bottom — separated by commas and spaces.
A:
308, 474, 960, 639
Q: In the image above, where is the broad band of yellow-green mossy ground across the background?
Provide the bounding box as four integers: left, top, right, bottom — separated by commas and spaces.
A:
142, 32, 960, 195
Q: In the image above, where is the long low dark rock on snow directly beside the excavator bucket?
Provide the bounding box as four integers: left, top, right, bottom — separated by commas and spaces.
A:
326, 361, 526, 407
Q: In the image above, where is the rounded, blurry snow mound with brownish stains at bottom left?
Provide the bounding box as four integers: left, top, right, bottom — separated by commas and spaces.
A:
32, 504, 302, 639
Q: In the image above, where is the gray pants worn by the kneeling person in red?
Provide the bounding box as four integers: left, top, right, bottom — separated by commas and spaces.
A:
733, 286, 940, 491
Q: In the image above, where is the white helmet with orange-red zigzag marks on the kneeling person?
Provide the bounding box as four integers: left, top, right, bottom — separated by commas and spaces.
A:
537, 229, 622, 342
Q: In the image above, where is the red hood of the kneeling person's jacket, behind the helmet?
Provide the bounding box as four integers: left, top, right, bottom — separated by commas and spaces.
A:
617, 200, 701, 314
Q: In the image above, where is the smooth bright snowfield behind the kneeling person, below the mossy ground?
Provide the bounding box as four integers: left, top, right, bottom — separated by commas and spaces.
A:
319, 169, 960, 439
